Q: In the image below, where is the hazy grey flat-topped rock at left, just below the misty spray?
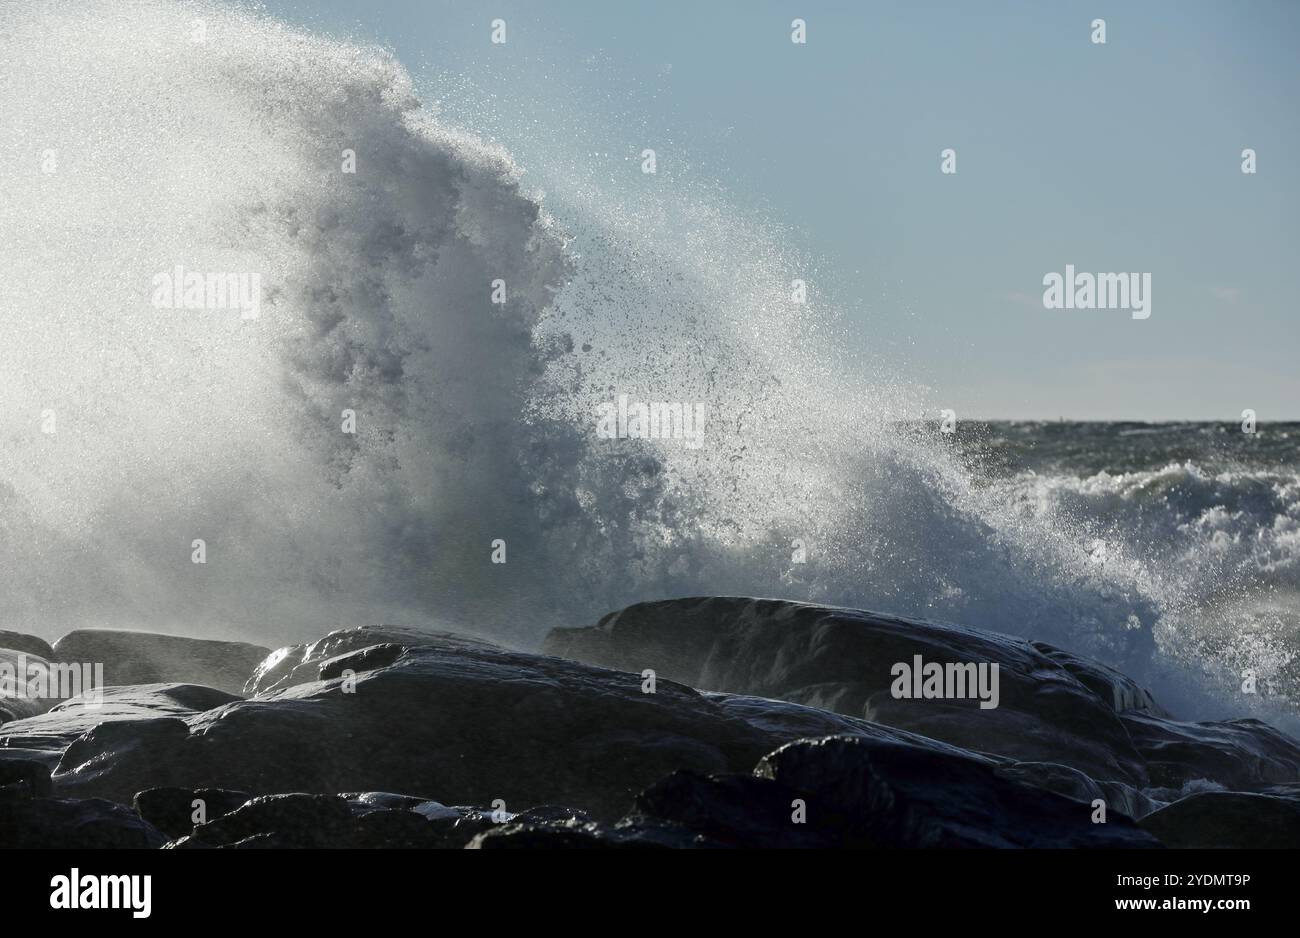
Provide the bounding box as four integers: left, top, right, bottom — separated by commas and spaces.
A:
53, 629, 269, 694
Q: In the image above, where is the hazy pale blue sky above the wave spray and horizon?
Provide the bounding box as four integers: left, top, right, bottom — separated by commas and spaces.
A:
258, 0, 1300, 421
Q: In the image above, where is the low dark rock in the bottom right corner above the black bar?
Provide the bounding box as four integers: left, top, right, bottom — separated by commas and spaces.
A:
1141, 791, 1300, 850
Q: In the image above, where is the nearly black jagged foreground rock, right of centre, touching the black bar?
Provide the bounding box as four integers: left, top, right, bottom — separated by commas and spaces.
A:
469, 737, 1160, 850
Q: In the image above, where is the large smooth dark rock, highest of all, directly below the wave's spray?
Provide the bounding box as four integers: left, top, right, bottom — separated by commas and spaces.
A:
545, 598, 1154, 787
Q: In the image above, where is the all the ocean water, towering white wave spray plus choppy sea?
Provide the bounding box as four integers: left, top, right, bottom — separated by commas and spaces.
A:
0, 0, 1300, 725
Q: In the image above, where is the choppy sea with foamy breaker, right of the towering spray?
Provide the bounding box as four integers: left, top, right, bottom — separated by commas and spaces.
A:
950, 421, 1300, 718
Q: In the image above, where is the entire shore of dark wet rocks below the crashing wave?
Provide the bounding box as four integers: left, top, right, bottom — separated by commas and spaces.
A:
0, 598, 1300, 850
